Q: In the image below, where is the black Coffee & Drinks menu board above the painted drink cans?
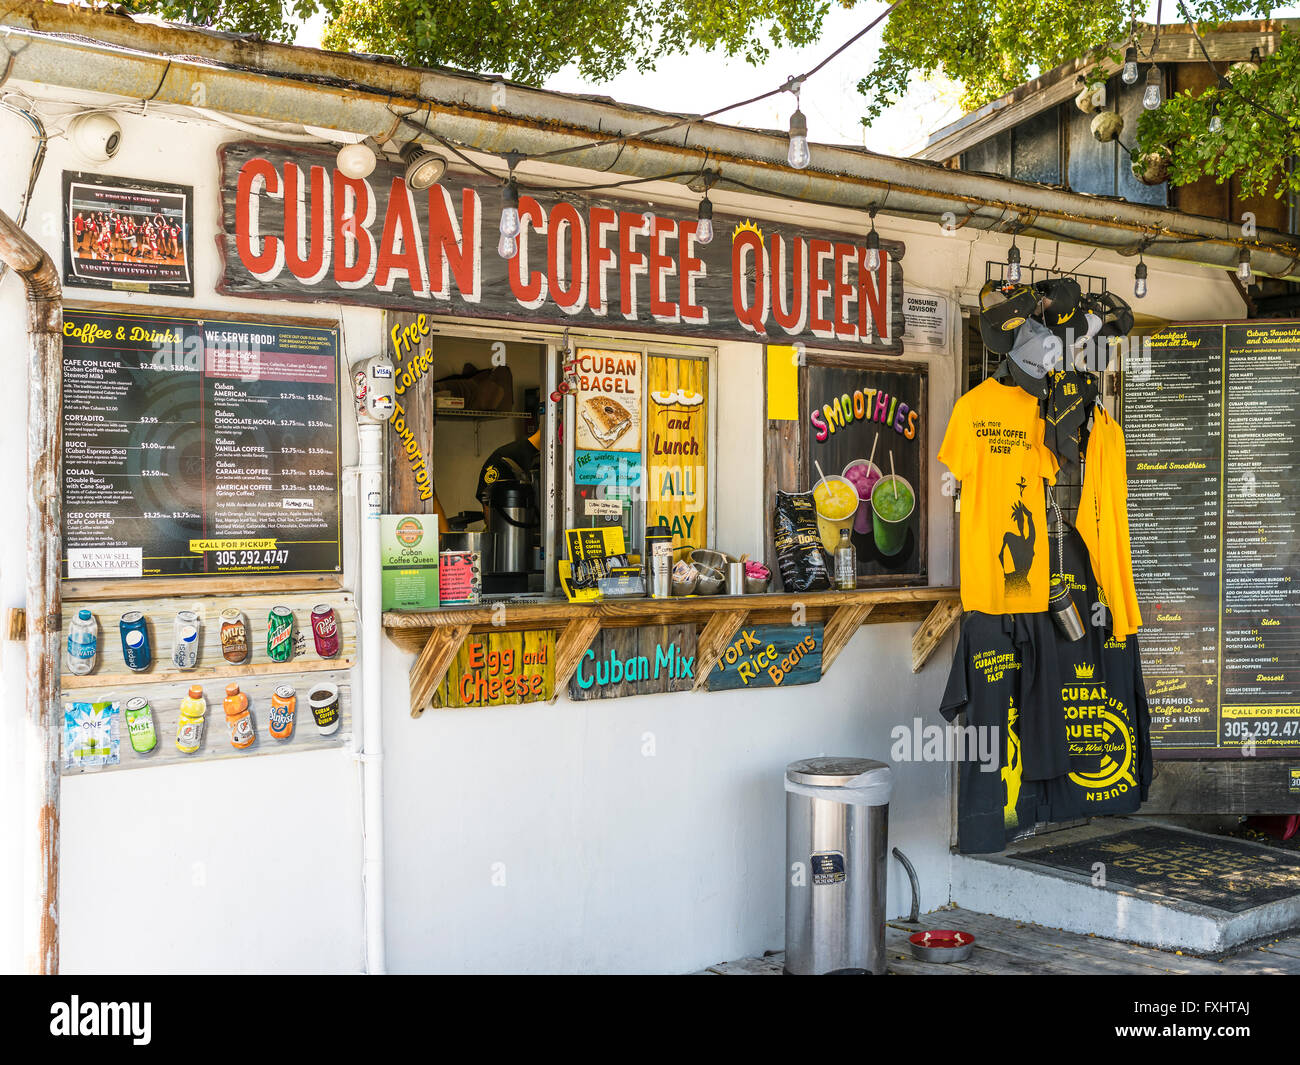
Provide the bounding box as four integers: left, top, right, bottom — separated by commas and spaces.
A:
62, 309, 342, 580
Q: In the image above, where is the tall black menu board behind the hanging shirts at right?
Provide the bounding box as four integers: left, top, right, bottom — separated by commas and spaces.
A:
1122, 322, 1300, 758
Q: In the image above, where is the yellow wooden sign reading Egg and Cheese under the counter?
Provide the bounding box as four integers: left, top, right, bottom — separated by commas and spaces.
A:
433, 628, 555, 710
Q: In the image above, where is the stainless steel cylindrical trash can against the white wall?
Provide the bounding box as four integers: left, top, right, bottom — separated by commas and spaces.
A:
785, 757, 892, 975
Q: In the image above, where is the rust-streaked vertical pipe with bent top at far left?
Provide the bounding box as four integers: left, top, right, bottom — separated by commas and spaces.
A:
0, 212, 64, 975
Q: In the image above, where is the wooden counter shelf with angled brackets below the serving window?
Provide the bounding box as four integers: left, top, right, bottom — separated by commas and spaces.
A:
384, 588, 962, 717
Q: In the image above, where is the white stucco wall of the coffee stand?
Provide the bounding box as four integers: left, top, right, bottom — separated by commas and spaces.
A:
0, 78, 1238, 973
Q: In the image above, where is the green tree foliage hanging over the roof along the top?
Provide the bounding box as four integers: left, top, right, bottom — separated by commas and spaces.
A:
124, 0, 1300, 195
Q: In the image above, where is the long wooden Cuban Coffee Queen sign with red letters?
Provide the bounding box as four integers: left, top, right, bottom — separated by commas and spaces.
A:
218, 142, 904, 354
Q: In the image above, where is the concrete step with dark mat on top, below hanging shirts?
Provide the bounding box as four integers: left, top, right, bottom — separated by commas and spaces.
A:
952, 818, 1300, 954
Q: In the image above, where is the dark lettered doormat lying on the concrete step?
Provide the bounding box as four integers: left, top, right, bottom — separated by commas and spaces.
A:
1013, 827, 1300, 913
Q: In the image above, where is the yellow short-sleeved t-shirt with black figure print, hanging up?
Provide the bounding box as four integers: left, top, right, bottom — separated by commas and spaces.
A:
939, 377, 1057, 614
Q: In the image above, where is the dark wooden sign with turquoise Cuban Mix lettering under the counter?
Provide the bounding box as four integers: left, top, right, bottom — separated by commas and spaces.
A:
569, 624, 696, 701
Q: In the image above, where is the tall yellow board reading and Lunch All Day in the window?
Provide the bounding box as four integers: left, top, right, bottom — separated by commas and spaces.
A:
645, 355, 710, 558
